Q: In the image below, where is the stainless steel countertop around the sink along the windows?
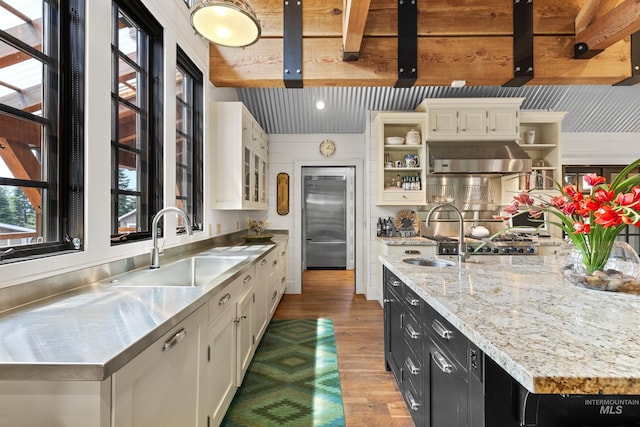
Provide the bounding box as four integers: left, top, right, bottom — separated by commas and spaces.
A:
0, 237, 280, 381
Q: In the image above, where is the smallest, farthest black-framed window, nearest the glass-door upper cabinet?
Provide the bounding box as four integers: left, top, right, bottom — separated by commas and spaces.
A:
176, 48, 203, 230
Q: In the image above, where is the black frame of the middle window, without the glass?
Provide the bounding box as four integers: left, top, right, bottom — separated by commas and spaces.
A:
110, 0, 164, 245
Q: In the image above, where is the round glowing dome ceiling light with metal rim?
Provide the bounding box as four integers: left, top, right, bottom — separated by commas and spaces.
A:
191, 0, 260, 47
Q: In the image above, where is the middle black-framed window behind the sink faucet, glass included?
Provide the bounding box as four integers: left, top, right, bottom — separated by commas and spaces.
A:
111, 1, 163, 243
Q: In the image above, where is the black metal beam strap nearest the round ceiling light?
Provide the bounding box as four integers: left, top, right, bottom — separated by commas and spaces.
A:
282, 0, 302, 88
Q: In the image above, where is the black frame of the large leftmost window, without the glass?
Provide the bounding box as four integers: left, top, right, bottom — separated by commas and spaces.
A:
0, 0, 86, 263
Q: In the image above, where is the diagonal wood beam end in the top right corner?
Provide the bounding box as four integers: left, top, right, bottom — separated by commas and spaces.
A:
575, 0, 640, 58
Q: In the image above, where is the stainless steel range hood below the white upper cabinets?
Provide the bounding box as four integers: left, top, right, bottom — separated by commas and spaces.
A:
427, 141, 531, 175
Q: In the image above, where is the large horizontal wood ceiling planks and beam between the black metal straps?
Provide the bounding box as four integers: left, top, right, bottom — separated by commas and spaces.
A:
210, 0, 640, 88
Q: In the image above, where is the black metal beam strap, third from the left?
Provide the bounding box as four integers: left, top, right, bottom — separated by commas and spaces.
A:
503, 0, 534, 87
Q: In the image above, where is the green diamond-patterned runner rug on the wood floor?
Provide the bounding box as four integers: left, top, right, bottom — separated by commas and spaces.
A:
221, 319, 345, 427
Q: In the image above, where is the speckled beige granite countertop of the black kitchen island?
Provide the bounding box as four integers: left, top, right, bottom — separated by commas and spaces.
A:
379, 255, 640, 394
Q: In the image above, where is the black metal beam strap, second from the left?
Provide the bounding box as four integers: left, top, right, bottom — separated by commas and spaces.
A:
394, 0, 418, 87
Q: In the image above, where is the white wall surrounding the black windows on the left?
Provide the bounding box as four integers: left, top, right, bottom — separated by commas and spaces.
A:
0, 0, 249, 287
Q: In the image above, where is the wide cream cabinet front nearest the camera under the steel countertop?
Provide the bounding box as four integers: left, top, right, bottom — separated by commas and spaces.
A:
112, 308, 206, 427
